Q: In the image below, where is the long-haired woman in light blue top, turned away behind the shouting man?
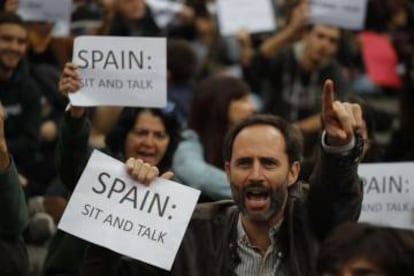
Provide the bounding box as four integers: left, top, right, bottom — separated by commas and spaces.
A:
172, 76, 256, 201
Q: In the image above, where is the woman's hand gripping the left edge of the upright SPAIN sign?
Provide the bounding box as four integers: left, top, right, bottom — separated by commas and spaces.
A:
59, 62, 85, 118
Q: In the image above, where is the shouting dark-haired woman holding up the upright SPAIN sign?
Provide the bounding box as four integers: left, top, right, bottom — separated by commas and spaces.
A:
45, 64, 180, 275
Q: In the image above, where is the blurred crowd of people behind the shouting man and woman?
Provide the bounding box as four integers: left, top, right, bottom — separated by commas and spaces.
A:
0, 0, 414, 275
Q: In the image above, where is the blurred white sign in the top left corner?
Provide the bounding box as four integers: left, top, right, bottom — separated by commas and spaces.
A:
17, 0, 72, 35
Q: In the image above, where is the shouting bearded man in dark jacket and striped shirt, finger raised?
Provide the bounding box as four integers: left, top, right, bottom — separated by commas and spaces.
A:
83, 81, 362, 276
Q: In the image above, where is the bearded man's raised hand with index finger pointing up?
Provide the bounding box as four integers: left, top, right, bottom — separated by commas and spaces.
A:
322, 80, 363, 146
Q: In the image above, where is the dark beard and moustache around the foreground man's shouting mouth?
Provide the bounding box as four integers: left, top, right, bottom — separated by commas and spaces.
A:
231, 181, 288, 223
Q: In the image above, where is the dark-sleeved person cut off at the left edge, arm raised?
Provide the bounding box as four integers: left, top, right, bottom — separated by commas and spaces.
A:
0, 104, 29, 276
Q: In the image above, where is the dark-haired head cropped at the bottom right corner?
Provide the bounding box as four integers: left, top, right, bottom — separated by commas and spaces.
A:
318, 223, 414, 276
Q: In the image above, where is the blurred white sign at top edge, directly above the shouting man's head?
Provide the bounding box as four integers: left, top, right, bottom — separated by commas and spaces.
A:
217, 0, 276, 36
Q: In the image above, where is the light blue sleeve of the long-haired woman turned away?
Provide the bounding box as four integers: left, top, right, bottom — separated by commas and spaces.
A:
172, 130, 231, 200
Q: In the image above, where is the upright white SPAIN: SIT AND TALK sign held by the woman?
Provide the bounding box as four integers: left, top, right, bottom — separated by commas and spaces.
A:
69, 36, 167, 107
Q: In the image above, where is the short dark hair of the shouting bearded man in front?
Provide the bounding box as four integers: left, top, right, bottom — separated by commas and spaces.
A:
223, 114, 303, 164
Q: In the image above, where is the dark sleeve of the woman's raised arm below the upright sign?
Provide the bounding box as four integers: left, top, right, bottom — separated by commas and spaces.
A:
56, 113, 92, 192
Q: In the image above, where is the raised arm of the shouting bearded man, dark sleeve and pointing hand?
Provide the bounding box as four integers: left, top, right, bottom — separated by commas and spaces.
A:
308, 80, 363, 239
